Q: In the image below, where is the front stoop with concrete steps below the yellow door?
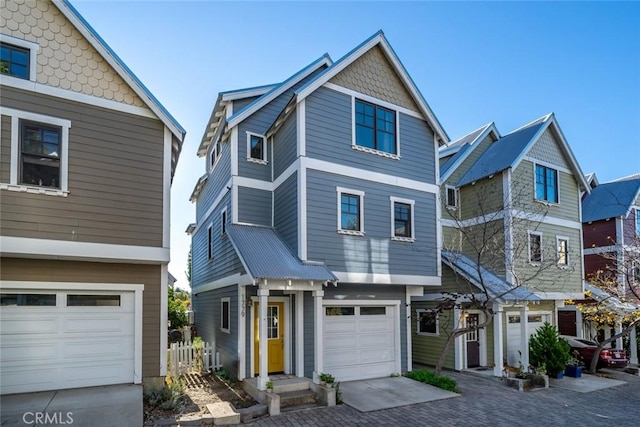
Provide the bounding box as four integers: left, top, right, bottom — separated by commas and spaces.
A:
243, 375, 336, 415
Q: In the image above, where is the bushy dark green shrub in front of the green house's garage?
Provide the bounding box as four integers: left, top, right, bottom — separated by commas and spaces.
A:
529, 322, 570, 376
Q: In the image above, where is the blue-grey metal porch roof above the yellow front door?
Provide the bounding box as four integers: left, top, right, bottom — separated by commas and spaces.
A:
227, 224, 338, 282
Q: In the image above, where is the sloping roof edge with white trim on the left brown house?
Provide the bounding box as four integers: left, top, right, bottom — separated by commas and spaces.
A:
53, 0, 186, 178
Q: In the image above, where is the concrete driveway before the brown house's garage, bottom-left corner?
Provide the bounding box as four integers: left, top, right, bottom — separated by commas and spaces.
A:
0, 384, 143, 427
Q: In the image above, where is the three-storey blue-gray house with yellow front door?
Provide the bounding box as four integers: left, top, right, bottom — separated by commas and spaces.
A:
188, 32, 448, 390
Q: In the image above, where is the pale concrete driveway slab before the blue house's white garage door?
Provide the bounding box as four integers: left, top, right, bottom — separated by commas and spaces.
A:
340, 377, 458, 412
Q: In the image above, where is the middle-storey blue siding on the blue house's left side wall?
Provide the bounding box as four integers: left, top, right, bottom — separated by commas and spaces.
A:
191, 194, 244, 291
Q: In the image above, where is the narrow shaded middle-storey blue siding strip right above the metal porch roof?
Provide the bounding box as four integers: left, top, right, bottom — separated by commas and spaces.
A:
273, 173, 298, 254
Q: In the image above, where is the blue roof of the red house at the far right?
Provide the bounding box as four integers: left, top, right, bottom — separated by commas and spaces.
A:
582, 178, 640, 222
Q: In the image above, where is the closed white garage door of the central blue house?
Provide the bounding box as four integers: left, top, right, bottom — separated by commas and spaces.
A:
323, 305, 400, 381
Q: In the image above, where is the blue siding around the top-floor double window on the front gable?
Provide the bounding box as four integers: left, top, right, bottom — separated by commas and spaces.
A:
306, 88, 436, 183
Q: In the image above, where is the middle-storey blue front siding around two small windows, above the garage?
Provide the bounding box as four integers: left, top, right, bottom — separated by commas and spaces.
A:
307, 170, 437, 276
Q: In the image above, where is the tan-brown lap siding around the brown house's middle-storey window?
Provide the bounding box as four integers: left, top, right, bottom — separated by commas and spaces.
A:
0, 87, 164, 247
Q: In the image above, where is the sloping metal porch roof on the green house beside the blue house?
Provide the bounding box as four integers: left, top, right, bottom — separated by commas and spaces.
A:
442, 251, 540, 301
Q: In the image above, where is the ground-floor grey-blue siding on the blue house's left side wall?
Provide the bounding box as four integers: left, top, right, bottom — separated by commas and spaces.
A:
193, 285, 239, 378
